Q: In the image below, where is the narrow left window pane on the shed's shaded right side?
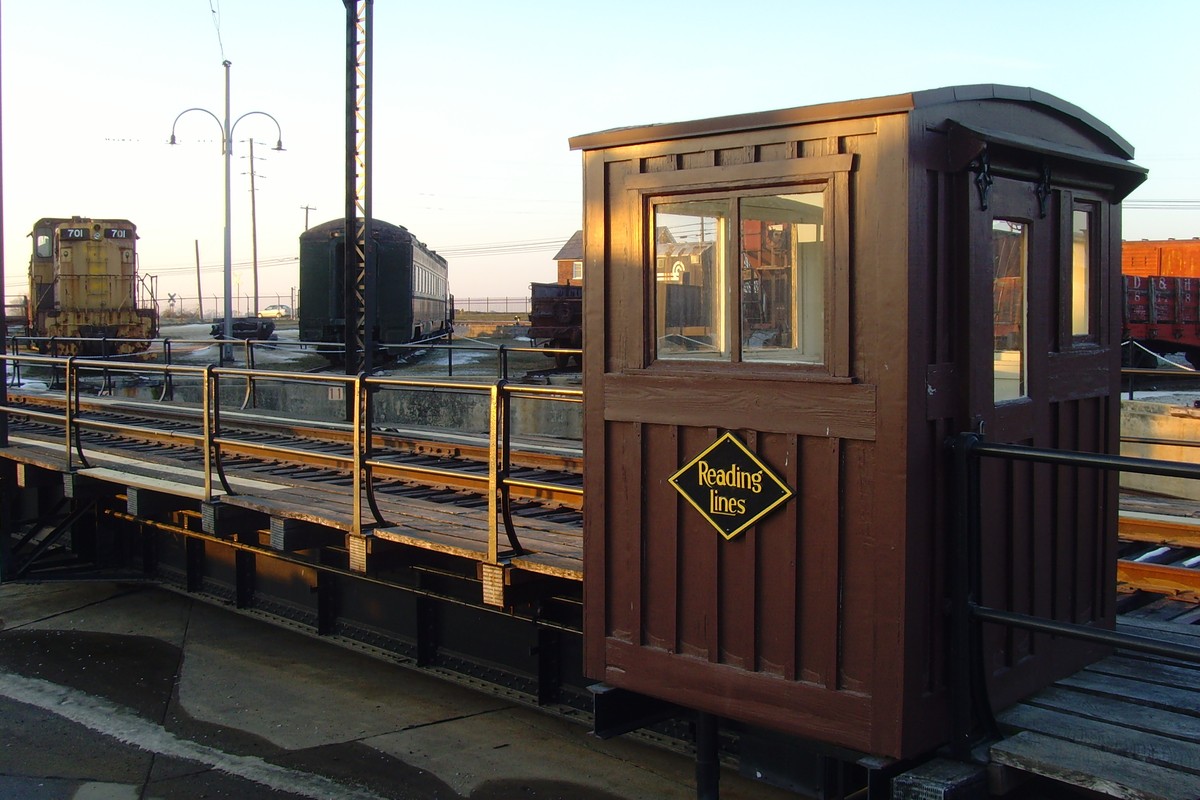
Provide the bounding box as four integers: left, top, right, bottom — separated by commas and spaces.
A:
991, 219, 1028, 403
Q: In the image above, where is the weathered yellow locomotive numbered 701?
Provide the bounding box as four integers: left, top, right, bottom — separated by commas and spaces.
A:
26, 217, 158, 355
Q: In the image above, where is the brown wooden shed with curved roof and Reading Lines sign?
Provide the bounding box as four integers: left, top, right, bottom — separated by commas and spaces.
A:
570, 85, 1145, 757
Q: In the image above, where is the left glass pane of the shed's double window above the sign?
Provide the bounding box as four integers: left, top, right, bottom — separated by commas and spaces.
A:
654, 200, 730, 360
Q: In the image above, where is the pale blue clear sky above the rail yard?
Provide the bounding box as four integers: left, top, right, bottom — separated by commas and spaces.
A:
0, 0, 1200, 307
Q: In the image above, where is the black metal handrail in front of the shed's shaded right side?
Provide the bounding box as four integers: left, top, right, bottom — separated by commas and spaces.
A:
947, 433, 1200, 758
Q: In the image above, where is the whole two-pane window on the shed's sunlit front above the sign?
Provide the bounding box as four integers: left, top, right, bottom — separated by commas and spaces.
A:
653, 184, 829, 365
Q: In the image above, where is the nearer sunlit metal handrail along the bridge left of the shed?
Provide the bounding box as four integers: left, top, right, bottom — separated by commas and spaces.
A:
0, 345, 583, 564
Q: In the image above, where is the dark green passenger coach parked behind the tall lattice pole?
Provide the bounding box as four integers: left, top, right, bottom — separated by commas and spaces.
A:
299, 219, 451, 361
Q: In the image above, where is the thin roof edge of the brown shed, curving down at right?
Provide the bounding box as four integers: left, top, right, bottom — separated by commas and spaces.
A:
569, 84, 1133, 158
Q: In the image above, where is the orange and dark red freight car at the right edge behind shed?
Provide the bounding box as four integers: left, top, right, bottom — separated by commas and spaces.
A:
1121, 239, 1200, 367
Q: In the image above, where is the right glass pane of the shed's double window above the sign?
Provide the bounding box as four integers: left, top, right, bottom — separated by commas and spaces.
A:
738, 192, 826, 363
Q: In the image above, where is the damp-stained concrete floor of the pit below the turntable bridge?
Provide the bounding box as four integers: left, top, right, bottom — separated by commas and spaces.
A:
0, 583, 796, 800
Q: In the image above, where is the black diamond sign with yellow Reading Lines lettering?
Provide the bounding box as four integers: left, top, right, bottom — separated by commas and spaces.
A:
671, 433, 794, 539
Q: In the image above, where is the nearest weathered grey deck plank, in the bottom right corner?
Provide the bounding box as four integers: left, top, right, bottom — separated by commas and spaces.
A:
991, 732, 1200, 800
